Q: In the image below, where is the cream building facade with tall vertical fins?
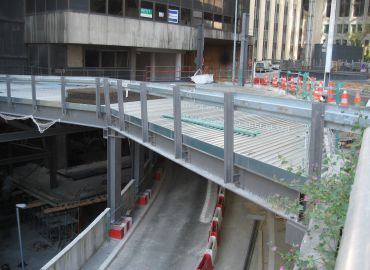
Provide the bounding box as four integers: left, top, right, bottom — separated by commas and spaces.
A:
249, 0, 303, 60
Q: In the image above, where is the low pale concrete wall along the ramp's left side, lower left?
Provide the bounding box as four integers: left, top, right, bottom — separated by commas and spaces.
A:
41, 208, 110, 270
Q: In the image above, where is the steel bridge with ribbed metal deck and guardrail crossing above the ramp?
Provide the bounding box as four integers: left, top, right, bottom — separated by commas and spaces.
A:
0, 75, 369, 220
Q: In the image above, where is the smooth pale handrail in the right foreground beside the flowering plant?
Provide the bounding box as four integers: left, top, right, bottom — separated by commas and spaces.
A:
335, 128, 370, 270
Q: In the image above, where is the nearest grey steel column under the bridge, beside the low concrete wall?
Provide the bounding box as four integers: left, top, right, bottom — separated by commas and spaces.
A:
107, 133, 122, 223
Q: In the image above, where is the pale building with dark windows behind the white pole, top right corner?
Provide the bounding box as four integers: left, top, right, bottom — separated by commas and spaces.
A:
306, 0, 370, 64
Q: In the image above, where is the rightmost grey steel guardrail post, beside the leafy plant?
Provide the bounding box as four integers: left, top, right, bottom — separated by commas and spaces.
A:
308, 102, 325, 180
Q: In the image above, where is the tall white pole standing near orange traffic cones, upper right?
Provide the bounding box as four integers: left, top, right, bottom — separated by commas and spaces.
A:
324, 0, 337, 86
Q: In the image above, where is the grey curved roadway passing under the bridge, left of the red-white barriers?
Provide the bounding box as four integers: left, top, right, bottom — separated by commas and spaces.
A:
109, 165, 209, 270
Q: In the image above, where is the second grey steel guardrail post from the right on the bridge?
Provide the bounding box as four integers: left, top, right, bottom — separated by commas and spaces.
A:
224, 92, 234, 183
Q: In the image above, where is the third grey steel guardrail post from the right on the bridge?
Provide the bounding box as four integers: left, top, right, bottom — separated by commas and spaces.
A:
173, 86, 182, 158
